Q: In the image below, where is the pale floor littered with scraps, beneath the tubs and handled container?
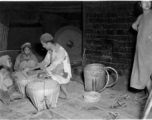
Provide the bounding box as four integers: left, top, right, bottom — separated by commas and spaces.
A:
0, 70, 152, 120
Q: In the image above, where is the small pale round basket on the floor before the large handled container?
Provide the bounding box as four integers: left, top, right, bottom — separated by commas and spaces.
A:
83, 91, 101, 103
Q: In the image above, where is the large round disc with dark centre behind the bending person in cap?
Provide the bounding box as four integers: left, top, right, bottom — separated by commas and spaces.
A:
54, 26, 82, 61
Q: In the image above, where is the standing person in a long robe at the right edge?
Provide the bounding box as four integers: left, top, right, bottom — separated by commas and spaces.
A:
130, 1, 152, 98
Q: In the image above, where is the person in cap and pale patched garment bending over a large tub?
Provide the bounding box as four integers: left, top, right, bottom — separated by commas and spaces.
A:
30, 33, 72, 99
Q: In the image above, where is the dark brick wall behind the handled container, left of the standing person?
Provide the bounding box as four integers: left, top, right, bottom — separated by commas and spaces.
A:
83, 1, 137, 74
